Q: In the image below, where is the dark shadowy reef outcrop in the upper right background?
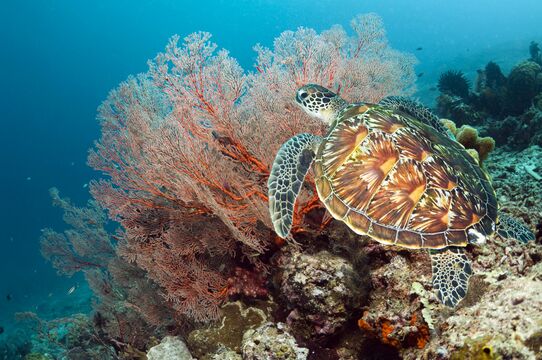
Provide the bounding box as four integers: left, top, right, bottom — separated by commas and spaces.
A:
436, 42, 542, 150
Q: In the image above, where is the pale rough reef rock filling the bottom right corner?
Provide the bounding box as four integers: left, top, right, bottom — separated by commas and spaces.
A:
432, 274, 542, 359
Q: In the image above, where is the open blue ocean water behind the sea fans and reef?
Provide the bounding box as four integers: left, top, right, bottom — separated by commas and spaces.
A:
0, 0, 542, 352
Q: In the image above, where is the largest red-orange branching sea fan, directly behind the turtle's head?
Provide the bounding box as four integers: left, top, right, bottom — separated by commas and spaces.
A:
89, 14, 415, 321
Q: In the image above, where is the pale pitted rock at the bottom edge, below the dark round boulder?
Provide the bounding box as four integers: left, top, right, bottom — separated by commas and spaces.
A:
242, 323, 309, 360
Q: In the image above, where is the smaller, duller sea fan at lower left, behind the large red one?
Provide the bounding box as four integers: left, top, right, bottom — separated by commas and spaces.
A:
41, 188, 177, 349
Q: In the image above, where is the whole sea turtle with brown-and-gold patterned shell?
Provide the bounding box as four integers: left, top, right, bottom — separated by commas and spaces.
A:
268, 84, 534, 307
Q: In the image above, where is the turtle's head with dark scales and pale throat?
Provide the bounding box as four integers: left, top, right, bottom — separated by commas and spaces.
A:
295, 84, 347, 124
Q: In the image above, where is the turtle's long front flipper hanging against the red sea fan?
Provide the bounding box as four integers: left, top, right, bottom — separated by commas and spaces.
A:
267, 134, 322, 238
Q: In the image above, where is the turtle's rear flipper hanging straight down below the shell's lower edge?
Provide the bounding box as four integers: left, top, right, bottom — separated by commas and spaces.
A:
429, 247, 472, 307
